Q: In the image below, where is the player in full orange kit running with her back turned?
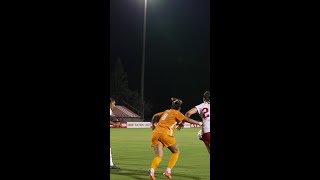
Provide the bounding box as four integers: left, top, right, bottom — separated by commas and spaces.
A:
149, 98, 202, 180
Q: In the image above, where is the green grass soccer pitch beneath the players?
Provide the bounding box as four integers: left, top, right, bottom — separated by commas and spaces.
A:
110, 128, 210, 180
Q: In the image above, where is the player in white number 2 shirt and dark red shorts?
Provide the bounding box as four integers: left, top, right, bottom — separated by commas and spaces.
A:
185, 91, 210, 154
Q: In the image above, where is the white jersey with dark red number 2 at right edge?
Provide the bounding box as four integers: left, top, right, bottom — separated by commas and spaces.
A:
196, 102, 210, 134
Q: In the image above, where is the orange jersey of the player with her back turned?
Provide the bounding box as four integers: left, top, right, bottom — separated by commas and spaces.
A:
154, 109, 186, 136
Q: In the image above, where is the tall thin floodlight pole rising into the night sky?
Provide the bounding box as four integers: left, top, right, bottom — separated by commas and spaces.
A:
141, 0, 147, 119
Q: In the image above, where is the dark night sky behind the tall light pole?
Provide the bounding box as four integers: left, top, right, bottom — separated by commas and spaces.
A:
110, 0, 210, 113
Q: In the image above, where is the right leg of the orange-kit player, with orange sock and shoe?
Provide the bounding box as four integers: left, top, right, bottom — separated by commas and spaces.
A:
163, 136, 180, 179
